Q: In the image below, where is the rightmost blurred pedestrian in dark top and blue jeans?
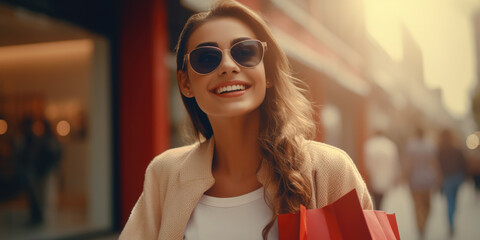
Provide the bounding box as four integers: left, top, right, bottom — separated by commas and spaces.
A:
437, 129, 466, 235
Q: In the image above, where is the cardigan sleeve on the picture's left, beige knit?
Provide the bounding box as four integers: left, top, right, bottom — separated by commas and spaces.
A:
119, 161, 162, 240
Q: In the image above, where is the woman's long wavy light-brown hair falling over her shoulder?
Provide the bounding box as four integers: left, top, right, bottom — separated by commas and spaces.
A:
176, 0, 315, 239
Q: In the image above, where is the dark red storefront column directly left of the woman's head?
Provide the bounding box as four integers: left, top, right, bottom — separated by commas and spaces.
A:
119, 0, 170, 225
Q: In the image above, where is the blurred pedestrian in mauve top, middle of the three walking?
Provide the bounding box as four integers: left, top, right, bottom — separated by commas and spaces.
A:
405, 128, 438, 238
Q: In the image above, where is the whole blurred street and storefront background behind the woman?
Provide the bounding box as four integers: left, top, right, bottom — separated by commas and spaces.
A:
0, 0, 480, 239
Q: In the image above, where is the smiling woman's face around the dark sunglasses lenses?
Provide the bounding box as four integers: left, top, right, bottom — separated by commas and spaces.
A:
179, 17, 267, 118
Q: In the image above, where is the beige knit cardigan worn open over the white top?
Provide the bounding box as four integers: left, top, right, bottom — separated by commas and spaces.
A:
120, 138, 372, 240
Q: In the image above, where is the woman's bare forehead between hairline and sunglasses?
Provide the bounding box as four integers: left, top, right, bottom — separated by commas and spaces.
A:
187, 17, 257, 50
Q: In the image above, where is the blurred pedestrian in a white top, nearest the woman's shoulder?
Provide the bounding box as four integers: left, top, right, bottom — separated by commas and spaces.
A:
365, 130, 400, 209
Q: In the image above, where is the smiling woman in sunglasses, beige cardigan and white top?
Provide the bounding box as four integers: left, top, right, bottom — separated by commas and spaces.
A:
120, 1, 372, 239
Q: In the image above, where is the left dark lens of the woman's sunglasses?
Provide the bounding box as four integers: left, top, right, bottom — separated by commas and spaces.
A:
190, 47, 222, 74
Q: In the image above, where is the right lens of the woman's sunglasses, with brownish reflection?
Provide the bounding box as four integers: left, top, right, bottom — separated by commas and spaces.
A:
230, 41, 263, 67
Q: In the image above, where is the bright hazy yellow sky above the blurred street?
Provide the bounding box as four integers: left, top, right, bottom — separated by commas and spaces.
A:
365, 0, 480, 117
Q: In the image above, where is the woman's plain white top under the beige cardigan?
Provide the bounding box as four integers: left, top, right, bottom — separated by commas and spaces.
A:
185, 187, 278, 240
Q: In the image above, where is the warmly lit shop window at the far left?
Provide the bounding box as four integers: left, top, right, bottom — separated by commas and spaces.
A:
0, 4, 112, 239
